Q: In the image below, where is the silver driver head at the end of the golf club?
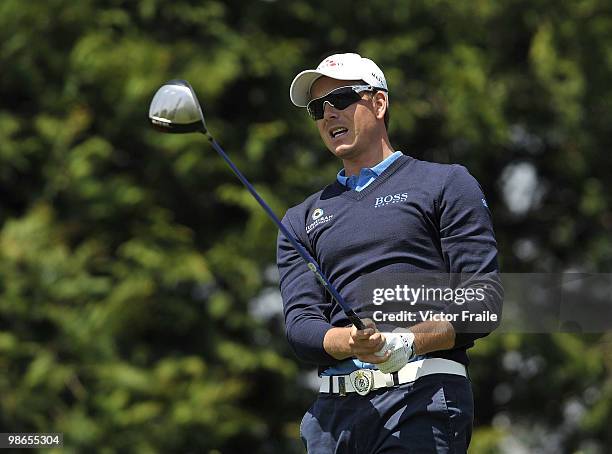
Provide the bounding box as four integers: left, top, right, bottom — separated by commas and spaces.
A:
149, 79, 206, 134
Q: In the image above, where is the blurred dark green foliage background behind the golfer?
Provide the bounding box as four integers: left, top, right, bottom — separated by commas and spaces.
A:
0, 0, 612, 454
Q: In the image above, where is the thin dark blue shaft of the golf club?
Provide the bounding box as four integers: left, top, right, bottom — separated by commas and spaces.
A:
205, 133, 365, 329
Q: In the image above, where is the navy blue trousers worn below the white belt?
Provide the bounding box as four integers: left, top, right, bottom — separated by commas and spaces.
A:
300, 374, 474, 454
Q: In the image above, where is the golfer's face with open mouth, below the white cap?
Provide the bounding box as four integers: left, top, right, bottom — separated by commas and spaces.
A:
310, 76, 380, 159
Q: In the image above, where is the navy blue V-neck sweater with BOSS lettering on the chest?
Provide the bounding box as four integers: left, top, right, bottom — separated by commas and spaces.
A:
277, 156, 503, 367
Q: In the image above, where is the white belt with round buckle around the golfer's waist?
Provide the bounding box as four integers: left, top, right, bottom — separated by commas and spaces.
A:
319, 358, 467, 396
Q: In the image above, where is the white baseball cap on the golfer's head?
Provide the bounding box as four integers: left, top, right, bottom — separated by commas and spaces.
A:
289, 54, 387, 107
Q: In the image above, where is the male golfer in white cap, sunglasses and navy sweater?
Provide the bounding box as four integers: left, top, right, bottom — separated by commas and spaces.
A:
277, 54, 502, 453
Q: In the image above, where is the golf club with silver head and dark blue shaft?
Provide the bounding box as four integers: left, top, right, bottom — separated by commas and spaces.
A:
149, 79, 365, 329
